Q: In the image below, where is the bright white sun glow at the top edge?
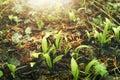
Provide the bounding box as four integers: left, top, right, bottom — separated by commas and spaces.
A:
26, 0, 73, 10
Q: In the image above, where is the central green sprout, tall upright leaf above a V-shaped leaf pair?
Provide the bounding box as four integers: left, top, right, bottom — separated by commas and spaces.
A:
42, 35, 63, 69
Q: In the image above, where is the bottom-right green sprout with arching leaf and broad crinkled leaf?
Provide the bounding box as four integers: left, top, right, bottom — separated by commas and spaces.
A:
85, 59, 108, 80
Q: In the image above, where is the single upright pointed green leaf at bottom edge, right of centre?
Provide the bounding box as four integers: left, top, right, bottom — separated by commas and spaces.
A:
71, 57, 79, 80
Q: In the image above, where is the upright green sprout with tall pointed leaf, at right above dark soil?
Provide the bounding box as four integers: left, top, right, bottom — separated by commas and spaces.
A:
94, 18, 111, 45
